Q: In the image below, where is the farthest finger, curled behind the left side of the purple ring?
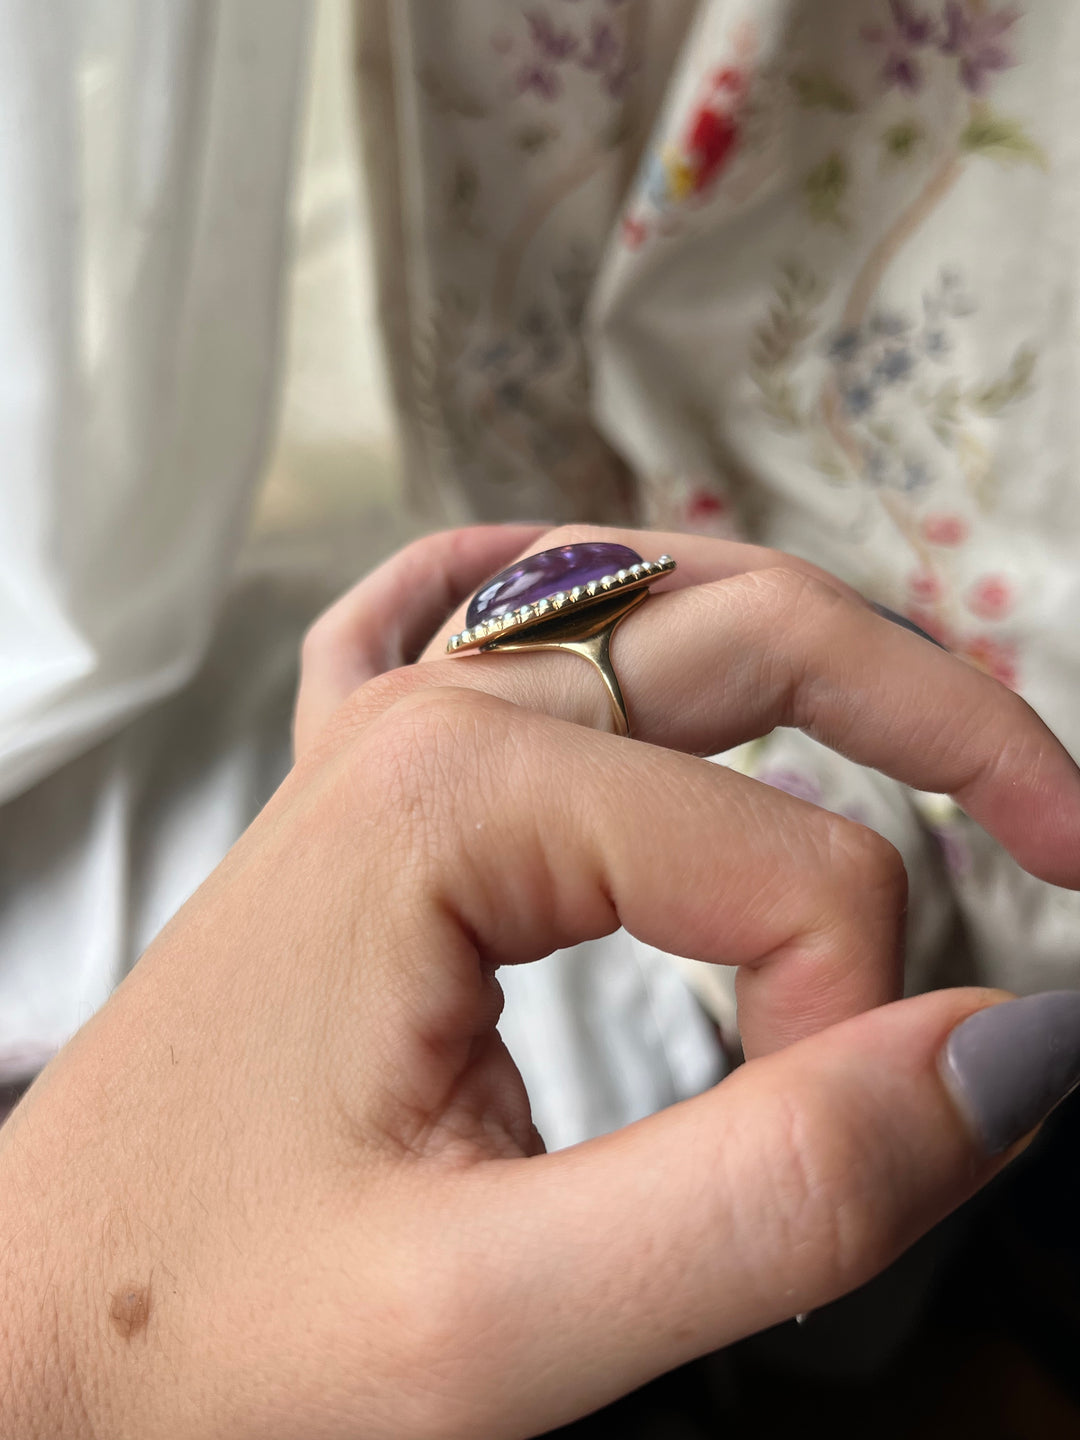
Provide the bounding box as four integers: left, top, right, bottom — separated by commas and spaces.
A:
294, 526, 543, 755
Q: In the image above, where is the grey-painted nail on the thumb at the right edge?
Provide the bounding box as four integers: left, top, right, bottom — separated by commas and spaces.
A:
942, 991, 1080, 1155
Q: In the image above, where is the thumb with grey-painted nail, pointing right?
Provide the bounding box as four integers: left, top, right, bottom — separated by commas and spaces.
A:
452, 989, 1080, 1434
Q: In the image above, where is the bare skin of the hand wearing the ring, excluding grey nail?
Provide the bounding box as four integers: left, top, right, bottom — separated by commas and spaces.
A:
0, 527, 1080, 1440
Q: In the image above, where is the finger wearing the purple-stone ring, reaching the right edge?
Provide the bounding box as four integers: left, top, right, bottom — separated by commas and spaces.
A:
403, 531, 1080, 887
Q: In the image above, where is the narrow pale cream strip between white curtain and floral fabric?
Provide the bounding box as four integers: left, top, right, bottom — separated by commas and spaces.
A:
251, 0, 420, 588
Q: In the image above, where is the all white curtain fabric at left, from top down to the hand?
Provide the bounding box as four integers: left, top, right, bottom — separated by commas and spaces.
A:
0, 0, 308, 1083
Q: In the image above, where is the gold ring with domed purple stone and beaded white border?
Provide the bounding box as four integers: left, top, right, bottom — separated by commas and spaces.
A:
446, 541, 675, 736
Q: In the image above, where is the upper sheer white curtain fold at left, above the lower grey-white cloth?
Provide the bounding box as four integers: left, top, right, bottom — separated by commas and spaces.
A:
0, 0, 308, 799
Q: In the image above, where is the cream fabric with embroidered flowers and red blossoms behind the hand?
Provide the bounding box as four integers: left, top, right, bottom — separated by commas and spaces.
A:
359, 0, 1080, 1018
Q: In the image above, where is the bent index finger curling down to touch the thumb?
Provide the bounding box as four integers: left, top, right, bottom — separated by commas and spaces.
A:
360, 690, 906, 1077
